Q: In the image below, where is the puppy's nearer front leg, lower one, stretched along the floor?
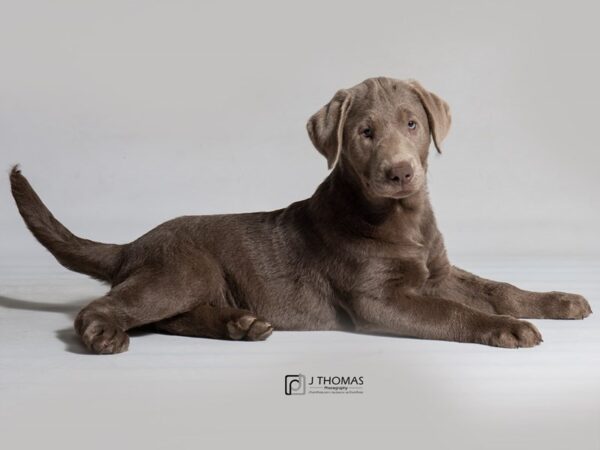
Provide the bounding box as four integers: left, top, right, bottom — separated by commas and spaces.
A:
352, 295, 542, 348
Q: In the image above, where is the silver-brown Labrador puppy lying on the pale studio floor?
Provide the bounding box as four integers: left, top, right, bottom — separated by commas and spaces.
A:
10, 77, 592, 354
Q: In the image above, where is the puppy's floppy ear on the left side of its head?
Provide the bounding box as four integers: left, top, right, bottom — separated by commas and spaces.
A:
306, 89, 352, 169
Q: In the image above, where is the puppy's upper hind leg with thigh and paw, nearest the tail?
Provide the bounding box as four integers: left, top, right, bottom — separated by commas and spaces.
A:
75, 266, 225, 354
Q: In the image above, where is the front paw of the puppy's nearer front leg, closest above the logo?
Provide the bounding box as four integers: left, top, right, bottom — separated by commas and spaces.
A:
479, 316, 543, 348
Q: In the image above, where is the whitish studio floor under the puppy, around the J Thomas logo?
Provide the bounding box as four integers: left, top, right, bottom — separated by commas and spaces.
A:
0, 258, 600, 450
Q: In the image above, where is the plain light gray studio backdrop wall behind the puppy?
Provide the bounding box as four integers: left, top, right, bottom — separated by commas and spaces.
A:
0, 1, 600, 263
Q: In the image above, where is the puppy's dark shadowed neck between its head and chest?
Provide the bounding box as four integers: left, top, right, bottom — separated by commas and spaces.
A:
309, 165, 430, 237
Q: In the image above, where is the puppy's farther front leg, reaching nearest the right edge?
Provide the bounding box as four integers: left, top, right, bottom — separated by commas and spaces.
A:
432, 267, 592, 319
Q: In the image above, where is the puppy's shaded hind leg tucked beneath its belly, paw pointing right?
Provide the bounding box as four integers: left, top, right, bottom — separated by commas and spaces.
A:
153, 305, 273, 341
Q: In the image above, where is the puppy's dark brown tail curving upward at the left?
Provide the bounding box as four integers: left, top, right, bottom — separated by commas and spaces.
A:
10, 166, 123, 281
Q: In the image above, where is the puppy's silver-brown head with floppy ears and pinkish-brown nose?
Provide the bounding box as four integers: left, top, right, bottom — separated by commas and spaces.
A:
307, 78, 450, 199
